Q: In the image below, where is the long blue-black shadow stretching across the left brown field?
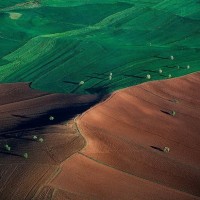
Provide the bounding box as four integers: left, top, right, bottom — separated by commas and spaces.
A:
0, 95, 105, 147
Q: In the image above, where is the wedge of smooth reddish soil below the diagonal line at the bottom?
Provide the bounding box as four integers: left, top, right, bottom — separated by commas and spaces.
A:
51, 154, 198, 200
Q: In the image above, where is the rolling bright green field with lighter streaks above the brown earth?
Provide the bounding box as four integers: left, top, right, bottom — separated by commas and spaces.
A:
0, 0, 200, 94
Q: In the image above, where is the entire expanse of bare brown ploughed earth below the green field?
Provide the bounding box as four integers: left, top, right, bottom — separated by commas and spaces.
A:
0, 73, 200, 200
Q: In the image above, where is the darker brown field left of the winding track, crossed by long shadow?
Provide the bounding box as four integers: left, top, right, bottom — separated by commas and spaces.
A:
0, 83, 99, 200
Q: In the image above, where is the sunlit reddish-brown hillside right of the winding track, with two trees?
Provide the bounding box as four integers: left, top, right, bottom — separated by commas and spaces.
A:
50, 73, 200, 200
